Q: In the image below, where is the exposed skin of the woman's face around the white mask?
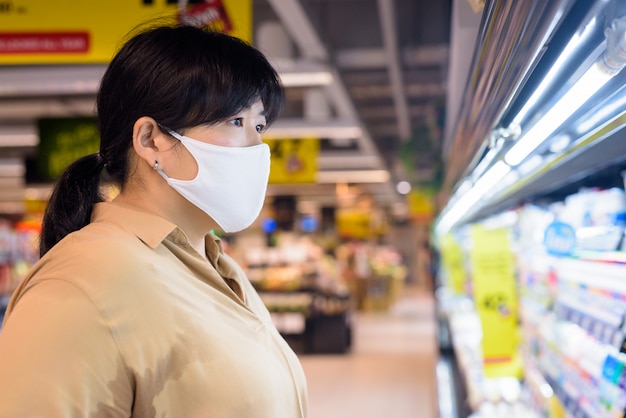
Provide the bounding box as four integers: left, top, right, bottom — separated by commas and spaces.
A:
164, 100, 267, 180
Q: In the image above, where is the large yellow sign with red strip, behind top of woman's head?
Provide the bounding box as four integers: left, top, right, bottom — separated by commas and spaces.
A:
0, 0, 252, 64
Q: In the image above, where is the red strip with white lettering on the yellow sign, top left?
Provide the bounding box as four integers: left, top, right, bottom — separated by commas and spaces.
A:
0, 32, 89, 54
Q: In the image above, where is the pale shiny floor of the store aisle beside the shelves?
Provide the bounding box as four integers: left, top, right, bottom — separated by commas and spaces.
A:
301, 288, 438, 418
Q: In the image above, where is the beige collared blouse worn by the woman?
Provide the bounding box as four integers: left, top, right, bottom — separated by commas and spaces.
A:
0, 203, 307, 418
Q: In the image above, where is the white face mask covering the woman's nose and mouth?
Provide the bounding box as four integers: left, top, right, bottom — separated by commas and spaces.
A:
159, 131, 270, 232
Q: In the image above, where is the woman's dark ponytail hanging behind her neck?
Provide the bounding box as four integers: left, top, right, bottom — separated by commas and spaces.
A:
39, 153, 104, 257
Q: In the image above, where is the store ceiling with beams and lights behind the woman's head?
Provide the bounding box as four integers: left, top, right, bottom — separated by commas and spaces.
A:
0, 0, 458, 216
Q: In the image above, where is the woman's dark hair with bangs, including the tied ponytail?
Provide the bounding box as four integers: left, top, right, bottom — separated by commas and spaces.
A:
39, 24, 283, 256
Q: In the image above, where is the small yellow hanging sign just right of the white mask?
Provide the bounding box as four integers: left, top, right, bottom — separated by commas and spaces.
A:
263, 138, 320, 184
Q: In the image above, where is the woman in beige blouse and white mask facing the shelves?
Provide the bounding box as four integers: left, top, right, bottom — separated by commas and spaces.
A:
0, 22, 307, 418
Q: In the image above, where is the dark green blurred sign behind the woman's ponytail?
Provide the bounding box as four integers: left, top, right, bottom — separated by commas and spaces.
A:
37, 117, 100, 180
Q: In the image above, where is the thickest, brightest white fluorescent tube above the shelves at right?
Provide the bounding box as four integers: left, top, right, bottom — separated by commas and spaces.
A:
504, 62, 612, 166
